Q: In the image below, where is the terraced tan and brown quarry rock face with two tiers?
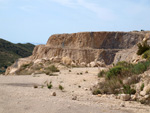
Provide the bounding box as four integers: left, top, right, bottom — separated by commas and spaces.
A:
4, 32, 149, 74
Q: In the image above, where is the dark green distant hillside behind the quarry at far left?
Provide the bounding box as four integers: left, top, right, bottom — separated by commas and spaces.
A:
0, 38, 35, 73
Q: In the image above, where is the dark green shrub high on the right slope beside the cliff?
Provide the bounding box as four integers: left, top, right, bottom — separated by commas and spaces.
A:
137, 41, 150, 55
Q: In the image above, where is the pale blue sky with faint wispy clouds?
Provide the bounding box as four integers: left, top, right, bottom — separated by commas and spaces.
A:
0, 0, 150, 44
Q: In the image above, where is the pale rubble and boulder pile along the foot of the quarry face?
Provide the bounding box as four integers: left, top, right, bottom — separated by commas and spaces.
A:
5, 56, 105, 75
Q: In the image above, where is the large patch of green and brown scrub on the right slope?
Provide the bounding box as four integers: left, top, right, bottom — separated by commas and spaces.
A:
95, 61, 150, 94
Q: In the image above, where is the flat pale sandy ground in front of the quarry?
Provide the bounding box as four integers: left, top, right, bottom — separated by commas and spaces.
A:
0, 68, 150, 113
